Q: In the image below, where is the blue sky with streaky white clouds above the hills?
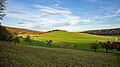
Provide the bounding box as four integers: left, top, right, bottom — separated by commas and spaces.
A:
2, 0, 120, 31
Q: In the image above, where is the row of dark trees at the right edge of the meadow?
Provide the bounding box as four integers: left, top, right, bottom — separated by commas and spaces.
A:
91, 41, 120, 53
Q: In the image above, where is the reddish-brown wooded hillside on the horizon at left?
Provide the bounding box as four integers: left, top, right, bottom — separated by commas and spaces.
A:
2, 26, 44, 34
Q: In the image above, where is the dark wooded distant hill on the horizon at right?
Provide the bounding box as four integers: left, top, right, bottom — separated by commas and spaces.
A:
82, 28, 120, 35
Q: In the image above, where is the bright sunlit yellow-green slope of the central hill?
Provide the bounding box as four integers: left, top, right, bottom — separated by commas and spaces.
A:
40, 31, 113, 42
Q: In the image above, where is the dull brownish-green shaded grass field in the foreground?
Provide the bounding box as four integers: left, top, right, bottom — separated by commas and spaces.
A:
0, 42, 120, 67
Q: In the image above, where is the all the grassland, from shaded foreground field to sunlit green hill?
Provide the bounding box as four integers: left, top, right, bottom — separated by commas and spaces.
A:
0, 31, 120, 67
